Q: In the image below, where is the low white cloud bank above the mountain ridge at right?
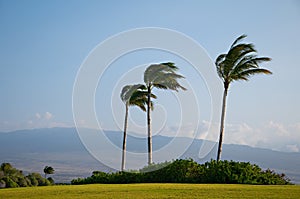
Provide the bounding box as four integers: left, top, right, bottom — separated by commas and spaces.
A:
157, 121, 300, 152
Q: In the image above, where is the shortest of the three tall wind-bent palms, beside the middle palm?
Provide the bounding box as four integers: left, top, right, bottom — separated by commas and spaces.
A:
120, 84, 156, 171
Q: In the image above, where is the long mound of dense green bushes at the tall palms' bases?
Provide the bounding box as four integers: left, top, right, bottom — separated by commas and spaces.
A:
71, 159, 290, 185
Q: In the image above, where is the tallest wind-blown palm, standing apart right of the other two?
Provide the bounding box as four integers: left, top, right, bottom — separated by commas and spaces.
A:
215, 35, 272, 161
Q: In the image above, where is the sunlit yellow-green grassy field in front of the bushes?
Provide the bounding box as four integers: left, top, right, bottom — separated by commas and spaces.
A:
0, 184, 300, 199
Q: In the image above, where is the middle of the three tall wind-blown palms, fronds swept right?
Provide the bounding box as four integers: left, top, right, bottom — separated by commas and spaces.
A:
144, 62, 186, 165
